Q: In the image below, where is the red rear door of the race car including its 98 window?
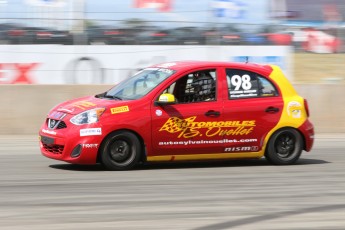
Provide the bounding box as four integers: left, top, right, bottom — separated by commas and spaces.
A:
223, 68, 284, 152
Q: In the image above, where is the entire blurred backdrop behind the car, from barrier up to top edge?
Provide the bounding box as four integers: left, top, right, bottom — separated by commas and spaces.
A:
0, 0, 345, 133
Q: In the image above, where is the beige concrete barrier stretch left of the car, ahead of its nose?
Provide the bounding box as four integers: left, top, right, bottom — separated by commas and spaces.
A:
0, 85, 111, 135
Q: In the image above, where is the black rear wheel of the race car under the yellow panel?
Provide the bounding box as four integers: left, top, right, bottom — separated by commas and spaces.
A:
265, 128, 303, 165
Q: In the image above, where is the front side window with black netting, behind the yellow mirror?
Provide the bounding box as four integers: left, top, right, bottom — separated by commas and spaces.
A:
164, 69, 216, 103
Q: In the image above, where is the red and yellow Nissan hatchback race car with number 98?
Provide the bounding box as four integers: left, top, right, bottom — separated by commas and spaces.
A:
39, 61, 314, 170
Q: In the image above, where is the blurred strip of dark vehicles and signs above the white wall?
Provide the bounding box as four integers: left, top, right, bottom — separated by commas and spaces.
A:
0, 0, 345, 49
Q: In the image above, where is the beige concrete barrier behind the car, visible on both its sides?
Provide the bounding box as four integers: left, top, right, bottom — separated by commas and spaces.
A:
0, 84, 345, 135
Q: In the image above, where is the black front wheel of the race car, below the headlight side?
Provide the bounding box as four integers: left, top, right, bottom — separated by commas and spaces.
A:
100, 131, 141, 171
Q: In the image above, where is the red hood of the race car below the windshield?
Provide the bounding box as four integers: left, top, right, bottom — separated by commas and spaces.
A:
53, 96, 128, 115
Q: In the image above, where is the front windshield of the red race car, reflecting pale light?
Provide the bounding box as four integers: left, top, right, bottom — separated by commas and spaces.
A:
104, 68, 175, 100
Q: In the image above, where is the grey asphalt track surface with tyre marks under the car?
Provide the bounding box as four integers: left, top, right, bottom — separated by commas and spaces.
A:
0, 136, 345, 230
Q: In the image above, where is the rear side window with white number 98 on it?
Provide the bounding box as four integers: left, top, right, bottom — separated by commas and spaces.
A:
226, 69, 278, 99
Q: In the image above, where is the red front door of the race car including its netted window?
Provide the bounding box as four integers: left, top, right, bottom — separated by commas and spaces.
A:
150, 68, 223, 155
